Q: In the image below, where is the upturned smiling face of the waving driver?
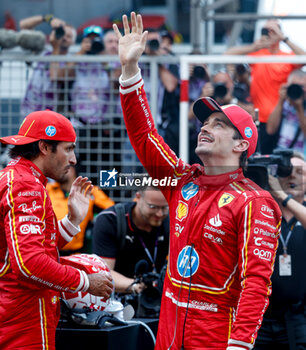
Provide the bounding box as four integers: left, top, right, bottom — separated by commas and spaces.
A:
195, 112, 239, 160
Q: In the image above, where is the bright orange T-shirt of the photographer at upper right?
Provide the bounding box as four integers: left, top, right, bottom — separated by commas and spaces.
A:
249, 49, 300, 123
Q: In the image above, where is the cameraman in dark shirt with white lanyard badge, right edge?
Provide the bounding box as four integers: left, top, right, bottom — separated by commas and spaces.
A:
254, 153, 306, 350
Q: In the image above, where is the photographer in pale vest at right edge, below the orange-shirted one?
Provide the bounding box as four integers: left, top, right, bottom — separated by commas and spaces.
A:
267, 70, 306, 153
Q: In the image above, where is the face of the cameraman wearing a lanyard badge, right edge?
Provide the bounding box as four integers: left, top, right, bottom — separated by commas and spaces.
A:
279, 157, 306, 198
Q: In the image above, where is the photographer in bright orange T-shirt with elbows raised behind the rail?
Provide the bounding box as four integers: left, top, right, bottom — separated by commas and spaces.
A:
224, 19, 305, 154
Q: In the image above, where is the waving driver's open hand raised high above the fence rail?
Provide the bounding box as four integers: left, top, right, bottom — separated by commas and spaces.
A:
113, 12, 148, 79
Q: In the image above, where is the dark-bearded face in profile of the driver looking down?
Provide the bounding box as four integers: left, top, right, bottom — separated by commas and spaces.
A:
43, 142, 76, 183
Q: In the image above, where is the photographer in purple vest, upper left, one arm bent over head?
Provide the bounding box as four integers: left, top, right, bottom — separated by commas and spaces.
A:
19, 15, 76, 118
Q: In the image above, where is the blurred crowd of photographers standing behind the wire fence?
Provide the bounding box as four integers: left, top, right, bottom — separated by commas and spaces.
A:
4, 15, 306, 170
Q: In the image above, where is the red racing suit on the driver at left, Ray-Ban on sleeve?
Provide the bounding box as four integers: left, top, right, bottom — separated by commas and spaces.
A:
0, 157, 84, 350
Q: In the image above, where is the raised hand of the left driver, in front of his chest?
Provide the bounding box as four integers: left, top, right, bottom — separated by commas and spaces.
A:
68, 176, 93, 226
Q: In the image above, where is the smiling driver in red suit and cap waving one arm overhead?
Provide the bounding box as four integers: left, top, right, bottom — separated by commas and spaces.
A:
113, 12, 281, 350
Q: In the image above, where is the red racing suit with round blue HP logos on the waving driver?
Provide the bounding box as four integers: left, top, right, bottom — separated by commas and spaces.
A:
121, 77, 281, 350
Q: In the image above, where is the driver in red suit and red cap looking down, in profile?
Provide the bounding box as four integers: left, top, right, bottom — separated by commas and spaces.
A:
0, 110, 112, 350
